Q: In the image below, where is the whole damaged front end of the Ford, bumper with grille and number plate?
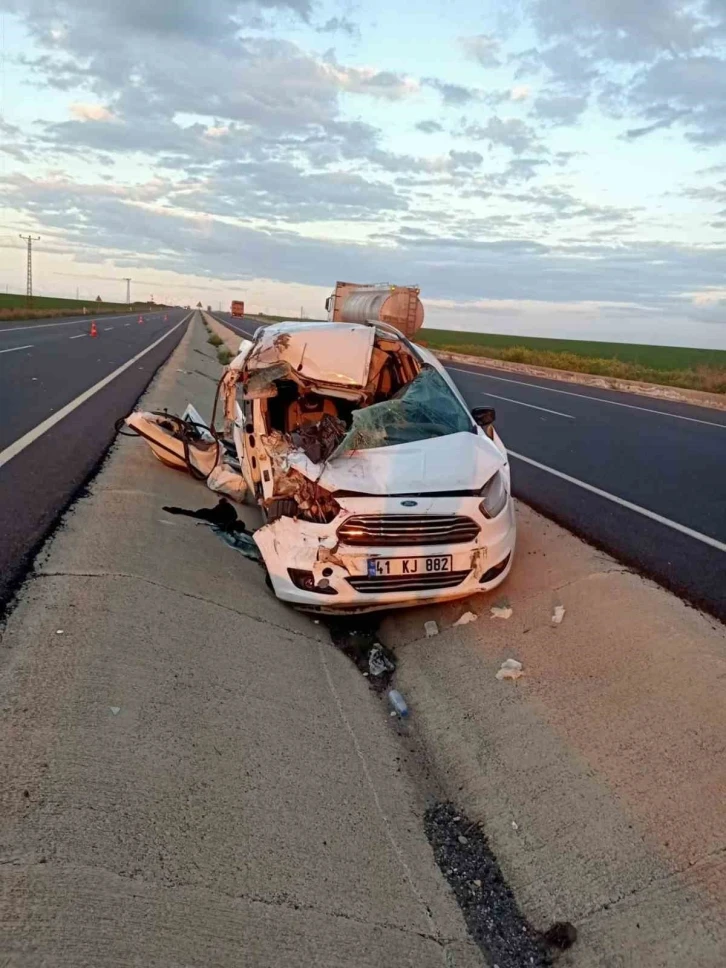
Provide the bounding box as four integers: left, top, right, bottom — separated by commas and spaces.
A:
255, 496, 516, 612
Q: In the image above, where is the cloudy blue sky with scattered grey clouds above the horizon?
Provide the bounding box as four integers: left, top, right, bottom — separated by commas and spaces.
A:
0, 0, 726, 347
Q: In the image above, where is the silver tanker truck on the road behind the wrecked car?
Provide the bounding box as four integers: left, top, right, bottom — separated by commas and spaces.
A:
325, 282, 424, 337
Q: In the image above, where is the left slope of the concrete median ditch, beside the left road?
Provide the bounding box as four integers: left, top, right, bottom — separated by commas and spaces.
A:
0, 320, 490, 968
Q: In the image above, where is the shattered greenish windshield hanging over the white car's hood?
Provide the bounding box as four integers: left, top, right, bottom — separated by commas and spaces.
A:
333, 366, 472, 457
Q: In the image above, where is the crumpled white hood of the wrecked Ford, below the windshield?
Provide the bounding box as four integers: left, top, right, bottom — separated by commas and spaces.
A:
289, 433, 506, 497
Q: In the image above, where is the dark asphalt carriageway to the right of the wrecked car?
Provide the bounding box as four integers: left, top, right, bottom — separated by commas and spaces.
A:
215, 313, 726, 621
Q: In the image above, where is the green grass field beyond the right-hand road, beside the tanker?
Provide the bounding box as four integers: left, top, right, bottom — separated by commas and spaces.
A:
417, 329, 726, 393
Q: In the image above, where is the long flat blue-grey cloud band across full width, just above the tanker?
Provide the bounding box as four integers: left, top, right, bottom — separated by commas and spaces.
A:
0, 168, 726, 318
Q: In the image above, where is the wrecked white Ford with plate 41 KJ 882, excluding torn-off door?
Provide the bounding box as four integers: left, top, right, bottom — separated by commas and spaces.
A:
225, 322, 515, 611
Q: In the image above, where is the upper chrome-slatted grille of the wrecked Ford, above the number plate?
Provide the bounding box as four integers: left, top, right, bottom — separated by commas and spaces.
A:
338, 514, 479, 548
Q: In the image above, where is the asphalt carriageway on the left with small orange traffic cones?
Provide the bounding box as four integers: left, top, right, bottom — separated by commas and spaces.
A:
0, 310, 190, 610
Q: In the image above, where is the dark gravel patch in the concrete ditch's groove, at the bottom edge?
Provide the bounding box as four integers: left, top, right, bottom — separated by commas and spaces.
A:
424, 803, 552, 968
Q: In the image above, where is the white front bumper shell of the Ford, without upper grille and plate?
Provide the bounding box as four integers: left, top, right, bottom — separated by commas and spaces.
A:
255, 497, 516, 612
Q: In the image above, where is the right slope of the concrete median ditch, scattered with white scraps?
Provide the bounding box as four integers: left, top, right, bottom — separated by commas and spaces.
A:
381, 504, 726, 968
